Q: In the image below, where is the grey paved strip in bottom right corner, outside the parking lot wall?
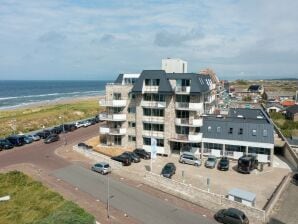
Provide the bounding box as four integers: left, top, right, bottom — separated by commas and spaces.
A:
269, 183, 298, 224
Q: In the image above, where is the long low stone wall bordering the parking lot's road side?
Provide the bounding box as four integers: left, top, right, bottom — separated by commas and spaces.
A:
144, 172, 266, 223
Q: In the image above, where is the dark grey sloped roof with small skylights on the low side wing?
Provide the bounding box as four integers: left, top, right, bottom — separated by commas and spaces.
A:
201, 109, 274, 144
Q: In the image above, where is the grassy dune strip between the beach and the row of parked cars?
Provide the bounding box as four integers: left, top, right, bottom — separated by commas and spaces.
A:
0, 100, 101, 137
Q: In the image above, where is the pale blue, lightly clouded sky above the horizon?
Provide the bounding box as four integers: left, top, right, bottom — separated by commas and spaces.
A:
0, 0, 298, 80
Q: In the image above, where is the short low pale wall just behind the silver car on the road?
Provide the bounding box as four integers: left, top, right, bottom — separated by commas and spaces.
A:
73, 145, 122, 169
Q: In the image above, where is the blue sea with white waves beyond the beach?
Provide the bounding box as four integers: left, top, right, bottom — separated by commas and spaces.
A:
0, 80, 109, 110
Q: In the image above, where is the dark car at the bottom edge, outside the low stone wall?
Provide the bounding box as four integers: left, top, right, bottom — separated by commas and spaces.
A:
214, 208, 249, 224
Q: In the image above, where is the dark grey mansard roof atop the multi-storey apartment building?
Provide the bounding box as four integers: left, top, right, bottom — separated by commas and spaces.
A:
131, 70, 212, 94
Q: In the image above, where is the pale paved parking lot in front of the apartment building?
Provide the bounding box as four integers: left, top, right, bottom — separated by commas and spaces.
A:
123, 155, 289, 209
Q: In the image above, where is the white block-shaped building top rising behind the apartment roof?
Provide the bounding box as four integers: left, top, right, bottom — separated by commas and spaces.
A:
161, 58, 187, 73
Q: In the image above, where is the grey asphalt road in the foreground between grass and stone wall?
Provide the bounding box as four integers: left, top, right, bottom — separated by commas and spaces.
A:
54, 165, 215, 224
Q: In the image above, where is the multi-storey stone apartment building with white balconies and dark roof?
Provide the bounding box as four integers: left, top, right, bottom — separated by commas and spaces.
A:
100, 70, 216, 154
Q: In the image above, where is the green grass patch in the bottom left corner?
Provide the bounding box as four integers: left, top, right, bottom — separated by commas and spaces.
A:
0, 171, 94, 224
